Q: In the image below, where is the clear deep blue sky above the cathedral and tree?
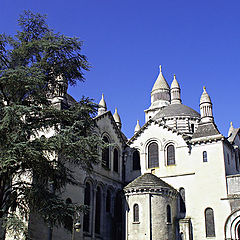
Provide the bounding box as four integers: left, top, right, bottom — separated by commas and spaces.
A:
0, 0, 240, 137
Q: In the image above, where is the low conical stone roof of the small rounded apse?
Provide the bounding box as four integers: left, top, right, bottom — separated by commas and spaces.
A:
124, 173, 174, 189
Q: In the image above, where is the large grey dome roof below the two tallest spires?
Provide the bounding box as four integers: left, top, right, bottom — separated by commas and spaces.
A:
153, 104, 200, 119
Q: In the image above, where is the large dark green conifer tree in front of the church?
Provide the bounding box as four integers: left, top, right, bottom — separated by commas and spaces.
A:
0, 11, 101, 238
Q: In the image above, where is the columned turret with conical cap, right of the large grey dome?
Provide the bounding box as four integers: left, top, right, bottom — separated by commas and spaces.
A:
200, 87, 213, 122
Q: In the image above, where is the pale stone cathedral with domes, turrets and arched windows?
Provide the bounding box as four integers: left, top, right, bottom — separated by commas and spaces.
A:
29, 67, 240, 240
